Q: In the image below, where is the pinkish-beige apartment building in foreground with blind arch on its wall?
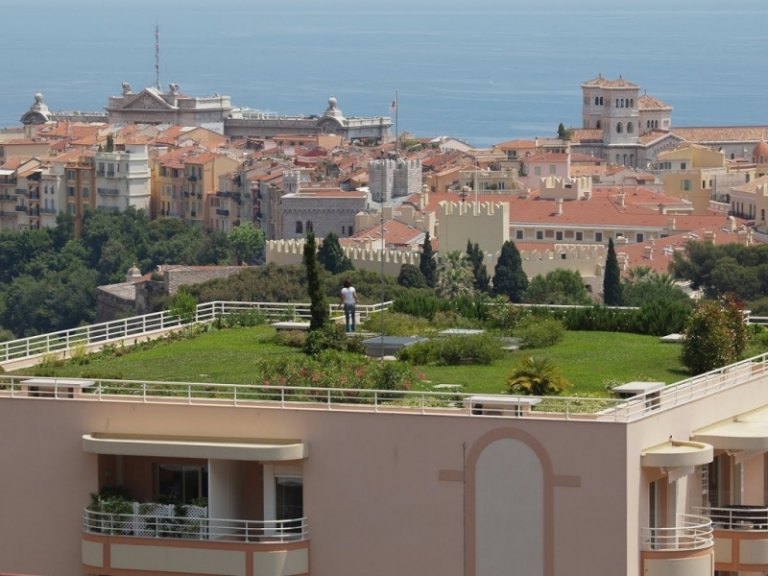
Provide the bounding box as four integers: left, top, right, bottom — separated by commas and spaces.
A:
0, 348, 768, 576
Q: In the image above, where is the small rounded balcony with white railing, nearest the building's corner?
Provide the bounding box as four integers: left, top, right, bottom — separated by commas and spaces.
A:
641, 514, 715, 576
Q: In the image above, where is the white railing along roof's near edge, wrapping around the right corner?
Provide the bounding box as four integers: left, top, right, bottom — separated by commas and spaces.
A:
0, 353, 768, 422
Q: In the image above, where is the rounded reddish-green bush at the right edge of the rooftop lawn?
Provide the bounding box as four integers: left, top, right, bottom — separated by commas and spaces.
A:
680, 297, 748, 375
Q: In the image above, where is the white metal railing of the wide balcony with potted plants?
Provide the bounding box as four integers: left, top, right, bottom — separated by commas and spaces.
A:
83, 502, 309, 543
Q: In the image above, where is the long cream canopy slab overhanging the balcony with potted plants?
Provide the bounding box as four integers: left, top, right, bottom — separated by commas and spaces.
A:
83, 432, 308, 462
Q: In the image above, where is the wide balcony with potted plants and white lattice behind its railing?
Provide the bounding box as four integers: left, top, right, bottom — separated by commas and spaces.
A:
81, 503, 309, 576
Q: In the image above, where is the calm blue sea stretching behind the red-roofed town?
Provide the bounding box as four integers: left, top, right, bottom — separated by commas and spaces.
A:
0, 0, 768, 146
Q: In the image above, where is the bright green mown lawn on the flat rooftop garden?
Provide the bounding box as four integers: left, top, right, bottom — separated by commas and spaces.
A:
18, 326, 687, 396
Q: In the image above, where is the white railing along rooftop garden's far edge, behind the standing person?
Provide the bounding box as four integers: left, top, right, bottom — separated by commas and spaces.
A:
0, 301, 392, 363
